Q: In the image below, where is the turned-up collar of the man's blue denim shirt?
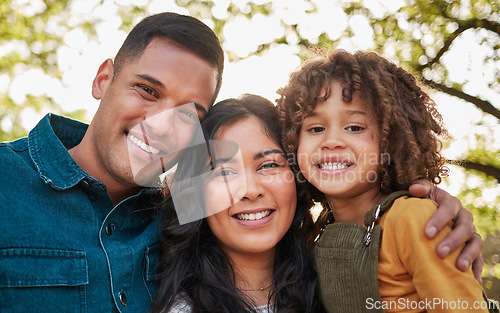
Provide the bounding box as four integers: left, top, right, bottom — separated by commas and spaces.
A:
28, 114, 93, 190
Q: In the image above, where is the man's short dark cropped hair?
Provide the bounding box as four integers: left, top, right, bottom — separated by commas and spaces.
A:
114, 12, 224, 101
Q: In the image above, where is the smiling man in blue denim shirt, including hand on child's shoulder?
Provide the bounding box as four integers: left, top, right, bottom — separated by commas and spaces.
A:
0, 13, 481, 312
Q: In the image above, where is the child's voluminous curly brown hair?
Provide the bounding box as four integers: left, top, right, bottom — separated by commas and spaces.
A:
278, 50, 448, 204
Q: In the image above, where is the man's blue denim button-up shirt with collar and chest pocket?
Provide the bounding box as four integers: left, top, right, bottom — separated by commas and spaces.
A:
0, 114, 159, 313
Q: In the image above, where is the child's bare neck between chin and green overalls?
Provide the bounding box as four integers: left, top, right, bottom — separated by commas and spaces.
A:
326, 188, 384, 225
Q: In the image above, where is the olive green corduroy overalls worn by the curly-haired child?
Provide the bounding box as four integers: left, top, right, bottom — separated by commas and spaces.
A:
314, 191, 409, 313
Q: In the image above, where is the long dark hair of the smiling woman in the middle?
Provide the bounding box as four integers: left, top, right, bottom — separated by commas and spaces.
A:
151, 95, 323, 313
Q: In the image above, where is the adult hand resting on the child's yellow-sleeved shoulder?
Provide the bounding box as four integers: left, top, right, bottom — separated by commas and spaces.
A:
410, 180, 483, 283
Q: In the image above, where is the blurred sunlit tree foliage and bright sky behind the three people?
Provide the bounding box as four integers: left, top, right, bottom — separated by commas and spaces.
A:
0, 0, 500, 300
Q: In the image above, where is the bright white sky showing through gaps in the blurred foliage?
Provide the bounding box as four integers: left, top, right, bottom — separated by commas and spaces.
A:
0, 0, 500, 201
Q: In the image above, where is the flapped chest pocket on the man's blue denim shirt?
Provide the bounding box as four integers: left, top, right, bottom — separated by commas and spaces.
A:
0, 248, 89, 313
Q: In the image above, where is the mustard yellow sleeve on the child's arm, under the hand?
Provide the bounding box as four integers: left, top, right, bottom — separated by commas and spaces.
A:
381, 197, 488, 312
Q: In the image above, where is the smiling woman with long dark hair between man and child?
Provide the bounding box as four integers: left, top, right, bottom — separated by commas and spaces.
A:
152, 95, 323, 313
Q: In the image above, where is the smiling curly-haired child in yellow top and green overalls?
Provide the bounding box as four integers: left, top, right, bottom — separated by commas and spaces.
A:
278, 50, 488, 312
